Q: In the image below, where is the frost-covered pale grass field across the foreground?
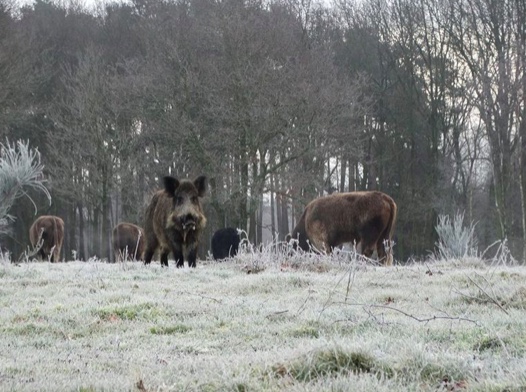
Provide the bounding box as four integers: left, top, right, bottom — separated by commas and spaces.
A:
0, 249, 526, 392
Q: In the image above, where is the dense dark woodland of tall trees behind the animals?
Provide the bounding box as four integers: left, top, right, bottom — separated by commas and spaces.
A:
0, 0, 526, 262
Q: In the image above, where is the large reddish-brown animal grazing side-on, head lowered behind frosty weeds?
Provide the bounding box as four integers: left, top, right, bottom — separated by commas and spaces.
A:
292, 191, 397, 265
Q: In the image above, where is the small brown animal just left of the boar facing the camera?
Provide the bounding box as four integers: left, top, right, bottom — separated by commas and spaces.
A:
111, 222, 145, 261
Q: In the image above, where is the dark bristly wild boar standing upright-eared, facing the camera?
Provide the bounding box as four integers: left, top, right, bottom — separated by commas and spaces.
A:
144, 176, 206, 268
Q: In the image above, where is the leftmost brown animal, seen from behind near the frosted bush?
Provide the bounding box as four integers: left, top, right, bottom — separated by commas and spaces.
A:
29, 215, 64, 263
